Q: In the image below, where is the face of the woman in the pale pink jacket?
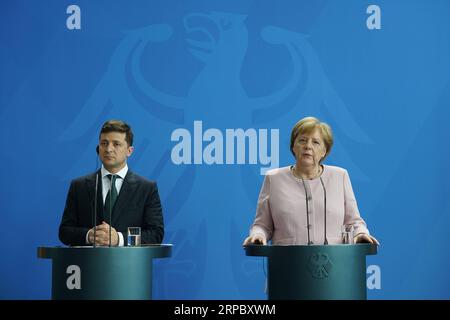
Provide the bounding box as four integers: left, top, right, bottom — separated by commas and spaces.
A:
294, 128, 326, 167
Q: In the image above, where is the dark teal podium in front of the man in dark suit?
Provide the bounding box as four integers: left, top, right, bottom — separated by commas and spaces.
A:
38, 244, 172, 300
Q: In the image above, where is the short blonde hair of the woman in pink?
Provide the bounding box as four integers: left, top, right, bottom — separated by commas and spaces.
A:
290, 117, 333, 162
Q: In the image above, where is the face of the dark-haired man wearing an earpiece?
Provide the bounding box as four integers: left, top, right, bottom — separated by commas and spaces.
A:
99, 132, 133, 173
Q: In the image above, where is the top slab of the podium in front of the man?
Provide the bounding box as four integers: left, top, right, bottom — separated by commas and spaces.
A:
37, 244, 173, 259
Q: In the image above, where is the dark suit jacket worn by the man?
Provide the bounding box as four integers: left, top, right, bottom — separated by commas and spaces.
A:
59, 170, 164, 246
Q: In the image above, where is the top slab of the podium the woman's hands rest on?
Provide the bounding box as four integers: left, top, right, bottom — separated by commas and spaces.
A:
244, 243, 378, 257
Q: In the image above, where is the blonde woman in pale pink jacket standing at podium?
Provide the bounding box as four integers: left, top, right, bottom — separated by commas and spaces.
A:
244, 117, 379, 245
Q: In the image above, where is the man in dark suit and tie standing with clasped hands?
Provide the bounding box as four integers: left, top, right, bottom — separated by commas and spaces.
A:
59, 120, 164, 246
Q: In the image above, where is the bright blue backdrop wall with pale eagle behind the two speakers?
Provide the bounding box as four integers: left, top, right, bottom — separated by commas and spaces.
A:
0, 0, 450, 299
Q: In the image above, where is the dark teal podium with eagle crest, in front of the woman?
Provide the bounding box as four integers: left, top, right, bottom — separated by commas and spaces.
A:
245, 244, 377, 300
